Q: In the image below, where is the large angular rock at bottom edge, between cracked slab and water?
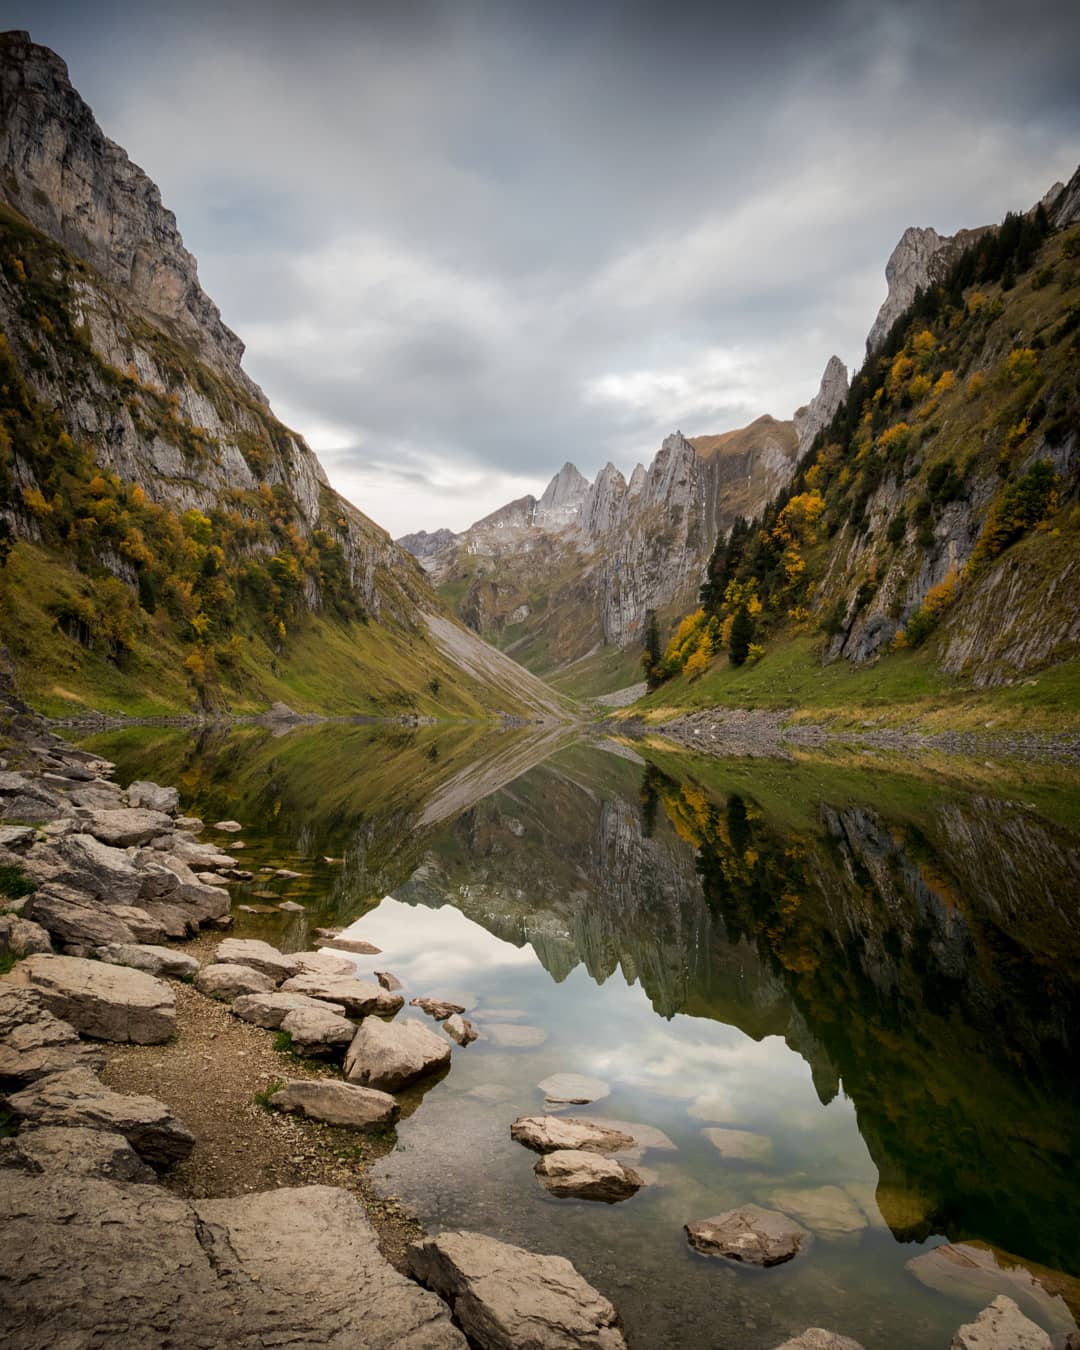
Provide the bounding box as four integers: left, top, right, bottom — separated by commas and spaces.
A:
409, 1233, 626, 1350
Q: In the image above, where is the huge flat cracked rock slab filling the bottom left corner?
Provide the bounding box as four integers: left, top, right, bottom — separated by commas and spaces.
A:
0, 1172, 466, 1350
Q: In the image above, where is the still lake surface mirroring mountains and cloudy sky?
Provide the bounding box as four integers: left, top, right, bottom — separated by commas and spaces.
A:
77, 724, 1080, 1350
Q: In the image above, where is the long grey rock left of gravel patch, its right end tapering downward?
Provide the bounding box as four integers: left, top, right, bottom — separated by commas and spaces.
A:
8, 1069, 194, 1166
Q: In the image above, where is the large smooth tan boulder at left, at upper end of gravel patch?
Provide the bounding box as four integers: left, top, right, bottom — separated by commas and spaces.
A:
14, 956, 177, 1045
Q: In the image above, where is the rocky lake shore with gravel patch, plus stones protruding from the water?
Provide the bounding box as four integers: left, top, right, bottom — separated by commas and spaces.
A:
0, 685, 1050, 1350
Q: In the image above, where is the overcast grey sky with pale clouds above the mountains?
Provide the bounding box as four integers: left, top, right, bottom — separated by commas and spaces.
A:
10, 0, 1080, 535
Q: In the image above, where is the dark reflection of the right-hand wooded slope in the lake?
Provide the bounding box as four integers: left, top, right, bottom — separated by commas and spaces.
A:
664, 780, 1080, 1270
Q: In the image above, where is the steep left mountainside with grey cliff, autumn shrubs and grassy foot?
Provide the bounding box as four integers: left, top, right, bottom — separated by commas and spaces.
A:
0, 32, 556, 713
